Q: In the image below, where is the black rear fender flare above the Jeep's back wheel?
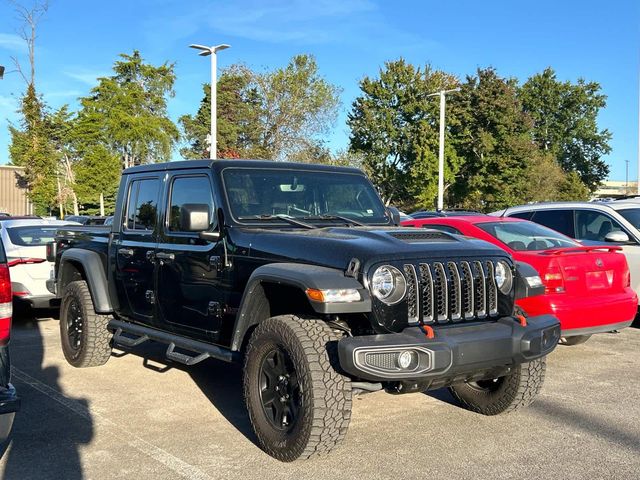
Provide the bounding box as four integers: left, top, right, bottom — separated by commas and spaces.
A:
56, 248, 113, 313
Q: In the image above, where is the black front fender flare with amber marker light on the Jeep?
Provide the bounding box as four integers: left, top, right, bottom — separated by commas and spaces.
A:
231, 263, 371, 351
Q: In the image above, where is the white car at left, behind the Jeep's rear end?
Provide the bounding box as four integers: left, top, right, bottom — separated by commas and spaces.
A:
0, 218, 79, 308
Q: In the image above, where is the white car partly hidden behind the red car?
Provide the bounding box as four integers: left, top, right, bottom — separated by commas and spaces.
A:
489, 200, 640, 295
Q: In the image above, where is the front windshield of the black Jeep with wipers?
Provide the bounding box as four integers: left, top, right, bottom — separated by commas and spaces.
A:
223, 168, 389, 224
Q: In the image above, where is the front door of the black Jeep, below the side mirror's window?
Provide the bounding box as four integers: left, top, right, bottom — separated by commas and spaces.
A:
156, 170, 224, 342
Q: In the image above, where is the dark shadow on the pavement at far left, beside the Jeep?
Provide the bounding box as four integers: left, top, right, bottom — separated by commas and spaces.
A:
2, 310, 93, 480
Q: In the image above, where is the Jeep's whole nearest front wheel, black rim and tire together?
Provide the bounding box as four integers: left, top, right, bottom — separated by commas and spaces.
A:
243, 315, 351, 462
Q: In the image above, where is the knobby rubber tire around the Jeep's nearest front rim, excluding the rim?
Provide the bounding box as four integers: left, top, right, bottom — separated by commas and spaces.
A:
243, 315, 351, 462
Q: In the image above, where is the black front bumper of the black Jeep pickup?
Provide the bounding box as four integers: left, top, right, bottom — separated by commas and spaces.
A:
338, 315, 560, 382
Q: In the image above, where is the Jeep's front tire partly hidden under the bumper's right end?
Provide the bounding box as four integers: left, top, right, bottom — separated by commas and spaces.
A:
449, 357, 547, 415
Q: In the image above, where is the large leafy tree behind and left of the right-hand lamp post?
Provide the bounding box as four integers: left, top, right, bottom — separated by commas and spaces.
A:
347, 59, 460, 208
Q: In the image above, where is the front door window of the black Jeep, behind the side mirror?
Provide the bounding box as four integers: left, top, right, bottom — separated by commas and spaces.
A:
168, 175, 215, 232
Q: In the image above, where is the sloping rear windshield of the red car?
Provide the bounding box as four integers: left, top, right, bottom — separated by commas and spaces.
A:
476, 221, 580, 251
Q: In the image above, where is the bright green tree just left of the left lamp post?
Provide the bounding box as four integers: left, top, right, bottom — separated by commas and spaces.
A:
77, 50, 179, 168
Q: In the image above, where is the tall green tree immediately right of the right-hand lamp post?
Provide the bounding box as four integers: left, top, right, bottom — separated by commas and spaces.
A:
451, 68, 538, 210
